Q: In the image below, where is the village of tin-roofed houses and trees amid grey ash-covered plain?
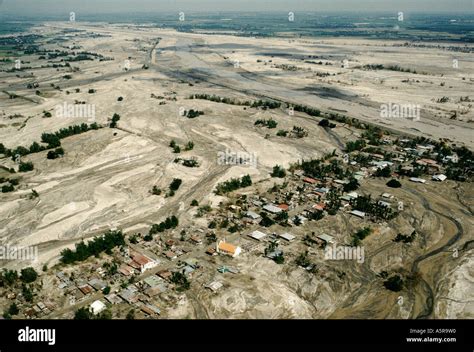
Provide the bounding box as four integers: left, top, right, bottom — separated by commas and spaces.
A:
0, 117, 472, 319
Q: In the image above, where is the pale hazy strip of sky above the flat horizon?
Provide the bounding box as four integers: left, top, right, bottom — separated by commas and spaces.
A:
0, 0, 474, 15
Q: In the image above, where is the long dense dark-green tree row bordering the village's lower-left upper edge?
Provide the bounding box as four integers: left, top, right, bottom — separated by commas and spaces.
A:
61, 231, 125, 264
